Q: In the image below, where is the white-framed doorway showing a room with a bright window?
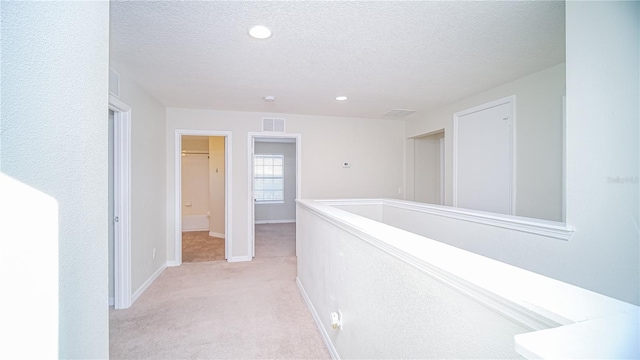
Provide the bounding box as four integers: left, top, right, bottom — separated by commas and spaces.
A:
248, 133, 301, 257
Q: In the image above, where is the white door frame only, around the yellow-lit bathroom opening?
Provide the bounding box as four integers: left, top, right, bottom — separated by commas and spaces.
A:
172, 129, 233, 266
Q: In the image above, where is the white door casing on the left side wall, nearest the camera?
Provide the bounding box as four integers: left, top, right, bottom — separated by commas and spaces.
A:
109, 95, 133, 309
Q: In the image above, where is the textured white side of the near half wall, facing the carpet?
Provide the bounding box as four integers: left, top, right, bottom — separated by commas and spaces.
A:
296, 206, 527, 359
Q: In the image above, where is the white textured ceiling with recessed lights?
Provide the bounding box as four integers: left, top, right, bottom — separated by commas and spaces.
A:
111, 1, 565, 118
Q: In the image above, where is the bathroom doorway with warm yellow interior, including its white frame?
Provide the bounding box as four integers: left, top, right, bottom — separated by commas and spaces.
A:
174, 130, 233, 266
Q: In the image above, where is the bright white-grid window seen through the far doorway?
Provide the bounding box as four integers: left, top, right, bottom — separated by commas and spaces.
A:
253, 155, 284, 202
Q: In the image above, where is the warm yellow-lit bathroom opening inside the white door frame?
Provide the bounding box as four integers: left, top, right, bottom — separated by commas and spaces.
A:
181, 135, 226, 263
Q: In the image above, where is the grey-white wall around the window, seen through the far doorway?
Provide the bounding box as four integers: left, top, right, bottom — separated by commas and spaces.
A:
254, 142, 296, 223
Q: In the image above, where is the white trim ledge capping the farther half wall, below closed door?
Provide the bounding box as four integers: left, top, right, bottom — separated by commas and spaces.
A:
316, 199, 575, 241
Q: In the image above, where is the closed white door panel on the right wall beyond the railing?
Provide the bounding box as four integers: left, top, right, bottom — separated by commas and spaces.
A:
453, 98, 515, 214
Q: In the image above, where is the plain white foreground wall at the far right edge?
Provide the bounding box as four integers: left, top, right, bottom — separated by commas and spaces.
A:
558, 1, 640, 304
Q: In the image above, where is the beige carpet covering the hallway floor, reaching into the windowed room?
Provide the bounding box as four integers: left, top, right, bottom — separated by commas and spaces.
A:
109, 224, 329, 359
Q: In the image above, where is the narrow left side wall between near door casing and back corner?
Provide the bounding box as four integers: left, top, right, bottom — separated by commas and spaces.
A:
112, 64, 167, 293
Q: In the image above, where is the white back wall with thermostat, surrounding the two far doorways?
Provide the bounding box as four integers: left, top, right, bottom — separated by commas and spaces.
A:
165, 108, 404, 260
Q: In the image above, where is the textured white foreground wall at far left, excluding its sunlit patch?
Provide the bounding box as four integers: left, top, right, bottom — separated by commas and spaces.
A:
0, 2, 109, 359
